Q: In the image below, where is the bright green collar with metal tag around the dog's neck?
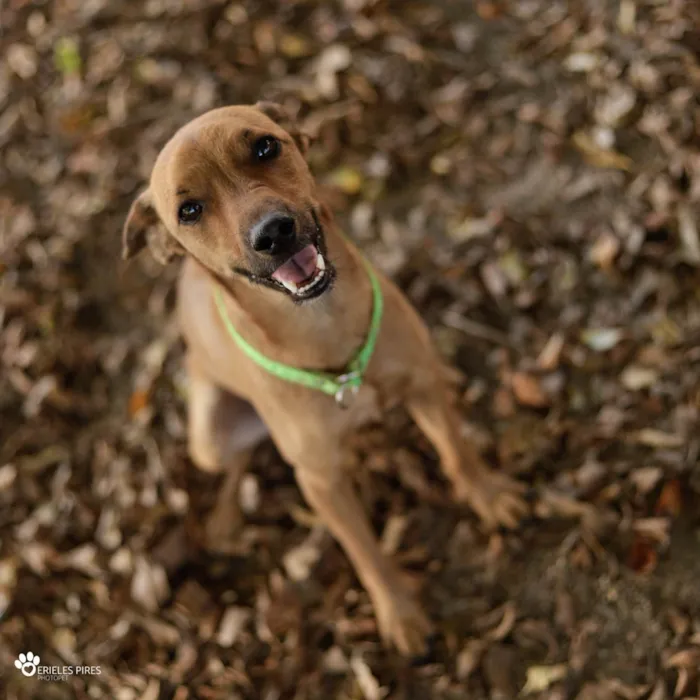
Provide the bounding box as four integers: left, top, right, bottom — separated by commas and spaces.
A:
214, 254, 384, 408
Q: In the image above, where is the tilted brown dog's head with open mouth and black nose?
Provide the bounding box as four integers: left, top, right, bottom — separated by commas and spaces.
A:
123, 103, 335, 301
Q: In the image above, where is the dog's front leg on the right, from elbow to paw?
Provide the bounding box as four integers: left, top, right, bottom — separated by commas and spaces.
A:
407, 373, 527, 528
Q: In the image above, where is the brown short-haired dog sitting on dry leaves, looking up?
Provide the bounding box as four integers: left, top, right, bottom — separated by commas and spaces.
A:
123, 103, 525, 654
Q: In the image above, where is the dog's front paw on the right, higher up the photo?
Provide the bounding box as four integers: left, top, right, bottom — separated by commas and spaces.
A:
455, 469, 530, 530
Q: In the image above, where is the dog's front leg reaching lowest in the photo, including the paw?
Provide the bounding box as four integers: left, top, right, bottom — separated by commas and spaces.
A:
296, 467, 431, 656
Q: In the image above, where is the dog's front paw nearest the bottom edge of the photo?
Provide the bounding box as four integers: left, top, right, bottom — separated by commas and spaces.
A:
374, 591, 433, 657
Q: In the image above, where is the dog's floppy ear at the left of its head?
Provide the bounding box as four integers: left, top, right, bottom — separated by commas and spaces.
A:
122, 189, 185, 265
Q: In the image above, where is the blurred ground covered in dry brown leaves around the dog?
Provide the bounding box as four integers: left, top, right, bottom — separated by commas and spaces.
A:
0, 0, 700, 700
